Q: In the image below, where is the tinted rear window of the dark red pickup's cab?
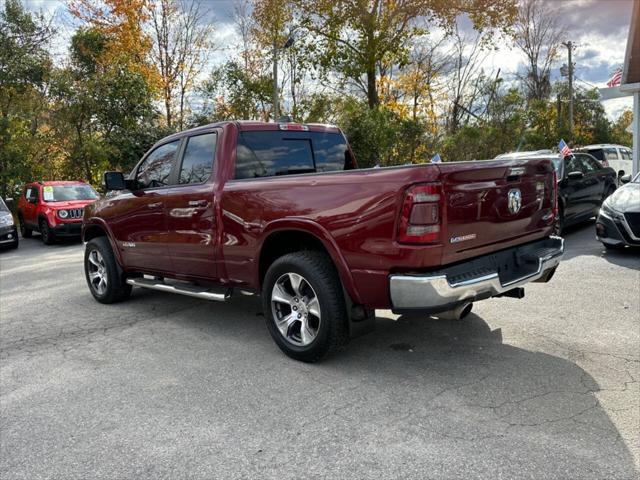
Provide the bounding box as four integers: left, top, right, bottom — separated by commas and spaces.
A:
235, 131, 354, 179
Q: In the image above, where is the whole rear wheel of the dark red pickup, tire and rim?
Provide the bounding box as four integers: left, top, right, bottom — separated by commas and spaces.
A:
262, 251, 348, 362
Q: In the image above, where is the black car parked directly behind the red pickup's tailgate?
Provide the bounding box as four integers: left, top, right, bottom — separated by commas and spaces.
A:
496, 151, 616, 235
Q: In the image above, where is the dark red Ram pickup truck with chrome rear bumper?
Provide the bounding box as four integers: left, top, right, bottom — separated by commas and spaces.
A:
82, 122, 563, 361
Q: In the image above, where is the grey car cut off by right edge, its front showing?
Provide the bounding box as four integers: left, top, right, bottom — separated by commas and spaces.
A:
596, 173, 640, 249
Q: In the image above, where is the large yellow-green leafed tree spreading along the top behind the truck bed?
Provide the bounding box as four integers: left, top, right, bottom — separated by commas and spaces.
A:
293, 0, 516, 108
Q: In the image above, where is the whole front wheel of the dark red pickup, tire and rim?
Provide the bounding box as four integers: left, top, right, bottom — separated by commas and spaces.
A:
84, 237, 131, 303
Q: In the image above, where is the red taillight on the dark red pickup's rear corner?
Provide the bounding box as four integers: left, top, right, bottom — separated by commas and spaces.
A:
398, 183, 443, 243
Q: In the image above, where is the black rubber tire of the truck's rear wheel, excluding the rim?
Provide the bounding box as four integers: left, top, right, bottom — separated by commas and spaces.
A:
262, 251, 348, 363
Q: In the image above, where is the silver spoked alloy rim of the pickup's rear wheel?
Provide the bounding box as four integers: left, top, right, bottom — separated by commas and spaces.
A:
271, 273, 321, 347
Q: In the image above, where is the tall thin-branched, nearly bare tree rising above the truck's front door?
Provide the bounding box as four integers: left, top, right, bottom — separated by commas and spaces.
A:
148, 0, 213, 129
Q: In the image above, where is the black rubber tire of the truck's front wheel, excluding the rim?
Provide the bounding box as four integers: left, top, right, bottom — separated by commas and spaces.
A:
84, 237, 131, 303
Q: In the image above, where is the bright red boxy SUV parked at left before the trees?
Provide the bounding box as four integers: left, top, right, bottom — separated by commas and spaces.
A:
18, 182, 99, 245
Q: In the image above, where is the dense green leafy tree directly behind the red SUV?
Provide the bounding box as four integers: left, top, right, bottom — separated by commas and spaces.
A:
51, 28, 155, 183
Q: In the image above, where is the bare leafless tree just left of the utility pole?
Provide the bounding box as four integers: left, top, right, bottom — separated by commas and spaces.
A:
514, 0, 564, 100
